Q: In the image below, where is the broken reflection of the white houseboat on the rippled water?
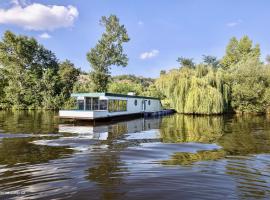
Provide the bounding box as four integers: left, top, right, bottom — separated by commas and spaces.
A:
58, 118, 161, 140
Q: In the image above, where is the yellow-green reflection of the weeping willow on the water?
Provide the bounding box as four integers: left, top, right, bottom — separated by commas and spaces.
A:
160, 114, 224, 143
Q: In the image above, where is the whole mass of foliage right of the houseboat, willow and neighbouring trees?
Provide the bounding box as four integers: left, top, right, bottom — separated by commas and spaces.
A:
156, 36, 270, 114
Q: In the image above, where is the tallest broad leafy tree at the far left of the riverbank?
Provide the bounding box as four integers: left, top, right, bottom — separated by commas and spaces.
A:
0, 31, 58, 108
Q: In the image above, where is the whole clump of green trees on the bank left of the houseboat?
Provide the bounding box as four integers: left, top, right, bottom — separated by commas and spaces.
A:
0, 31, 78, 109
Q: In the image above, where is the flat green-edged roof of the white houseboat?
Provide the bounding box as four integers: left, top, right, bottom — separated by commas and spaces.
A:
71, 92, 159, 100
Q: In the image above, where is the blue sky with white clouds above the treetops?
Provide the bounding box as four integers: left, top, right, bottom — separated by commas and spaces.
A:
0, 0, 270, 78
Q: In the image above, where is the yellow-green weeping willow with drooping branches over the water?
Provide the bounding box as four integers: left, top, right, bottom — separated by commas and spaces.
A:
156, 64, 230, 114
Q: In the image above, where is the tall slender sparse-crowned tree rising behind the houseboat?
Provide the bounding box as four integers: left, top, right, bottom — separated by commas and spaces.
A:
87, 15, 130, 92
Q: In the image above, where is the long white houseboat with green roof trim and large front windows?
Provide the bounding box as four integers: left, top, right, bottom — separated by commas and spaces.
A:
59, 93, 163, 120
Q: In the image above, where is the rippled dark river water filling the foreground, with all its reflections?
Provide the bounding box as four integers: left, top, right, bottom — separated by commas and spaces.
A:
0, 111, 270, 200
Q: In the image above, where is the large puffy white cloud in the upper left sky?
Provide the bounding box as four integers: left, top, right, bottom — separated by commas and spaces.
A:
0, 0, 79, 31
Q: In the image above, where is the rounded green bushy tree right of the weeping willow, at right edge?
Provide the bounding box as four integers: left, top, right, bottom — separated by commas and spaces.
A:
227, 57, 270, 113
